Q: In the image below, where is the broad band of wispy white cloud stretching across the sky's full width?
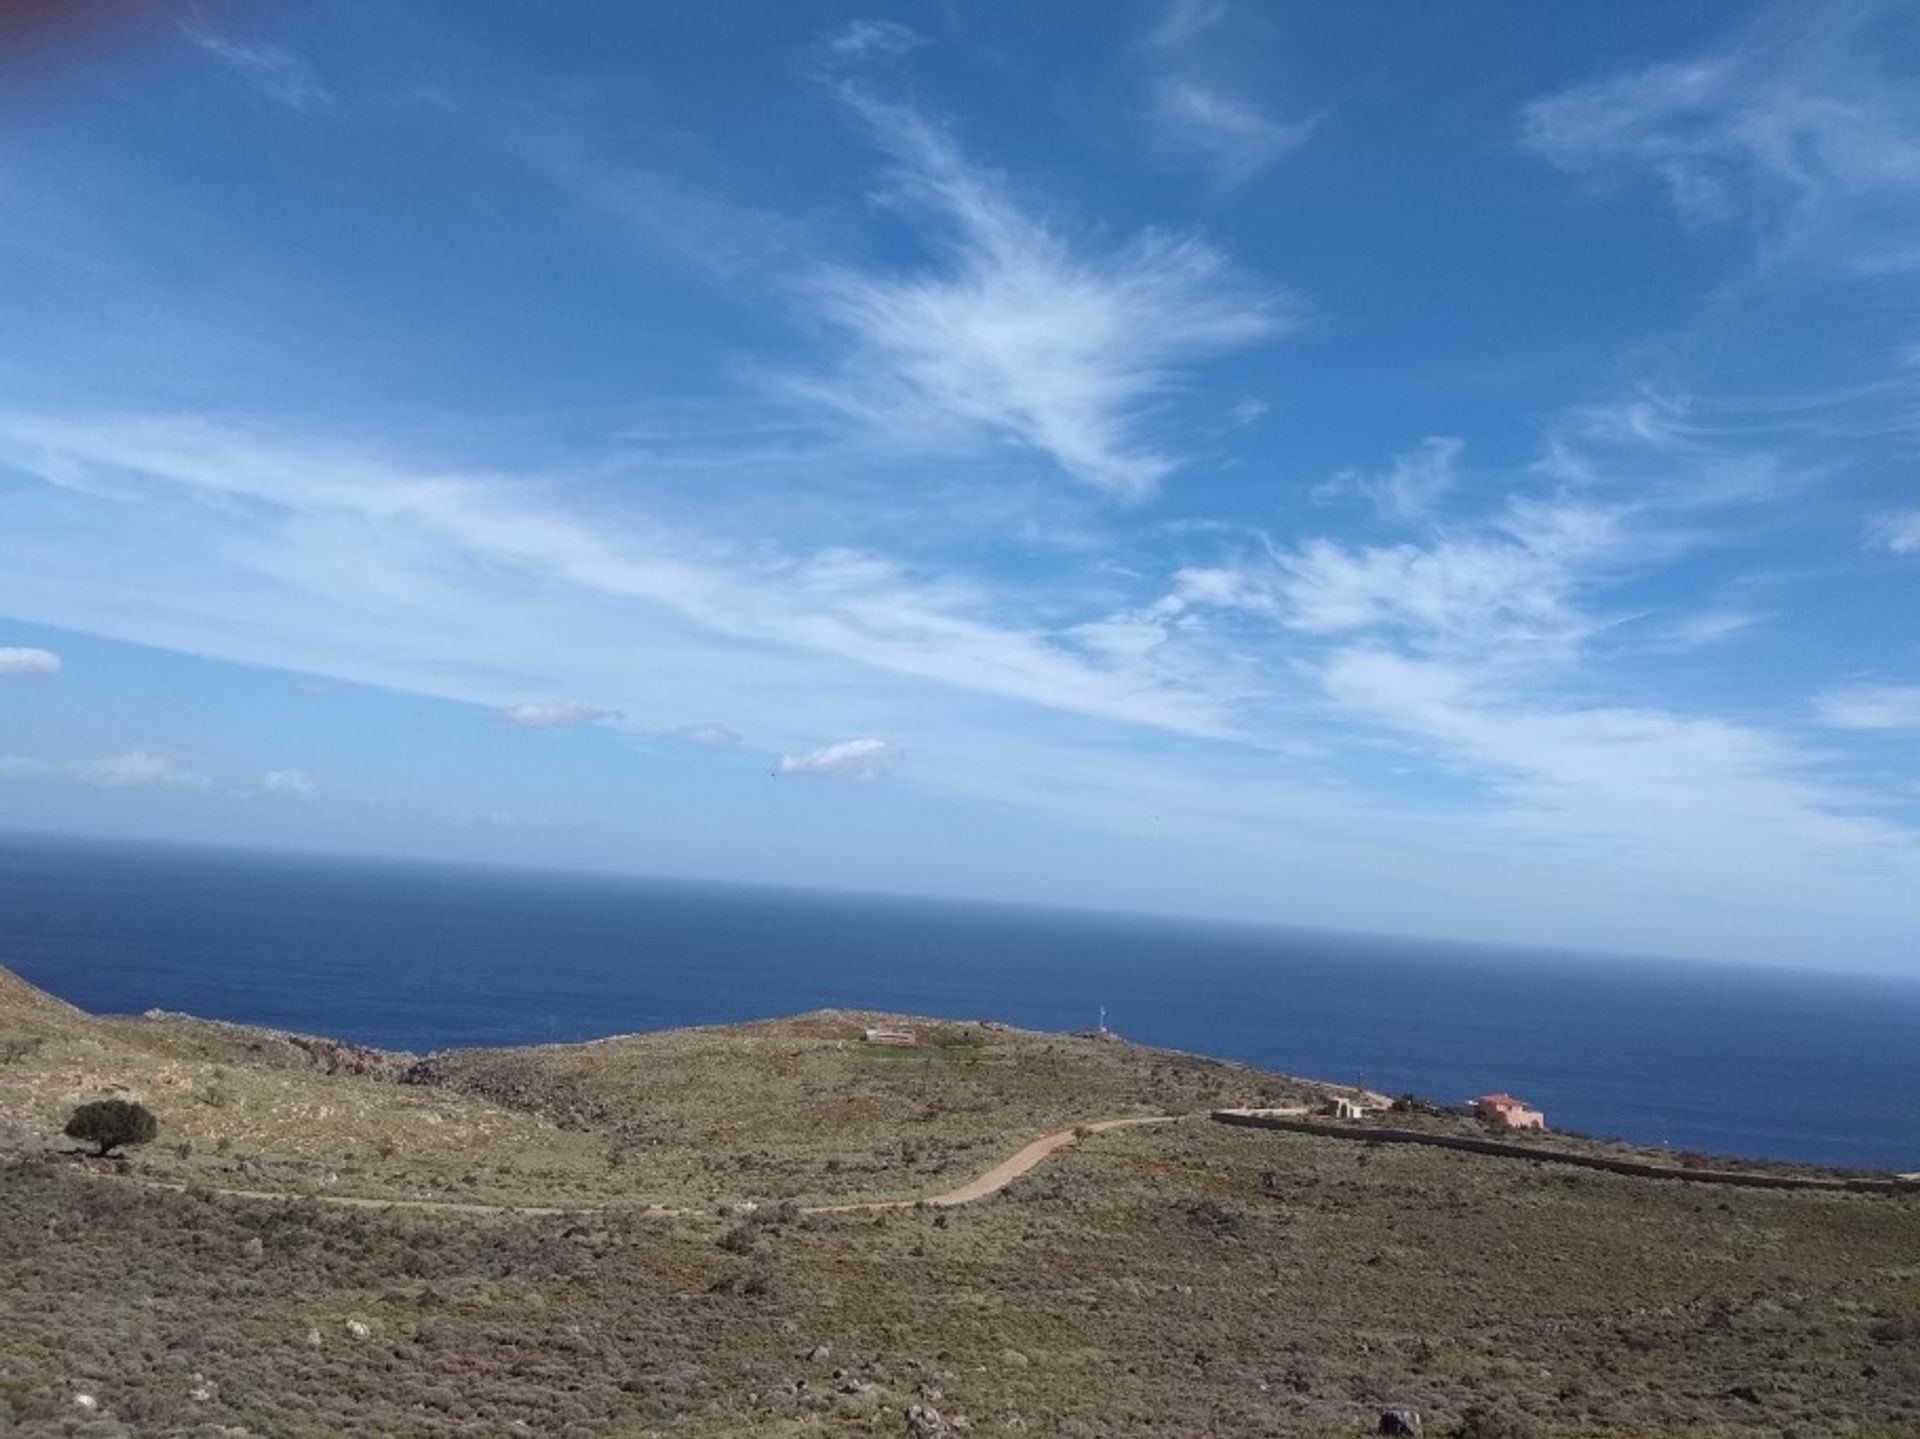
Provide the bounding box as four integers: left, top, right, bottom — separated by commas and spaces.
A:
0, 397, 1910, 960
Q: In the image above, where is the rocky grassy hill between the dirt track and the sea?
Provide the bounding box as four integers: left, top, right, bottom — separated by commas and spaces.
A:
0, 970, 1315, 1207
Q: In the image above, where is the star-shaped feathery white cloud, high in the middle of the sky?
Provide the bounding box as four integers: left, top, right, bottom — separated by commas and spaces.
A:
793, 86, 1283, 498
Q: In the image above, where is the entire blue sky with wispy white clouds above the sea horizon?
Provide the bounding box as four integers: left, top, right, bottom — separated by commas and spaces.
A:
0, 0, 1920, 968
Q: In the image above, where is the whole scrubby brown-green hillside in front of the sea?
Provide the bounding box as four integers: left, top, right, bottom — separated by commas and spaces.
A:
0, 974, 1920, 1439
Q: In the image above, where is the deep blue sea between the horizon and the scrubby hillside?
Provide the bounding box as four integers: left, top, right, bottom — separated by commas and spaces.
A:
0, 836, 1920, 1170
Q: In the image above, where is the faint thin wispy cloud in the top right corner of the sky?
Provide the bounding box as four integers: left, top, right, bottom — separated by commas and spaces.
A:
1521, 2, 1920, 271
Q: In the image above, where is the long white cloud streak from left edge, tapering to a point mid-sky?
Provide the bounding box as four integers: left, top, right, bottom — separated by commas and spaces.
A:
0, 415, 1233, 736
